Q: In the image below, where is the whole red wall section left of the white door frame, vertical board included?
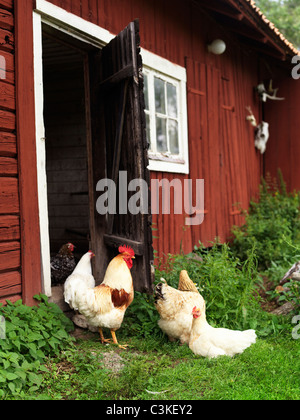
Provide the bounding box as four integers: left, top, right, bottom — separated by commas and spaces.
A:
0, 0, 41, 304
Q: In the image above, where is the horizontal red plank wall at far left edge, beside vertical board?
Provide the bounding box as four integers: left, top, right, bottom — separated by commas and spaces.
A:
0, 0, 21, 302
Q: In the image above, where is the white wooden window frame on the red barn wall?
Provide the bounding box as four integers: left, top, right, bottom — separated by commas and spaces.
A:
141, 49, 189, 174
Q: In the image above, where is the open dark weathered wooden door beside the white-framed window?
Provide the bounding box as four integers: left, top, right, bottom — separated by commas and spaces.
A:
89, 21, 153, 292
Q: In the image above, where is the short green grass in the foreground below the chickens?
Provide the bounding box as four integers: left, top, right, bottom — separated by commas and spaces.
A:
17, 333, 300, 400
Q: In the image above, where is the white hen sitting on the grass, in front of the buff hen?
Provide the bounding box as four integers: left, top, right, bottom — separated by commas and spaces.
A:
189, 307, 256, 358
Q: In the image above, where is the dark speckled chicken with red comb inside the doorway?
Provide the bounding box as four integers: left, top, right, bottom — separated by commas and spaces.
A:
50, 242, 76, 286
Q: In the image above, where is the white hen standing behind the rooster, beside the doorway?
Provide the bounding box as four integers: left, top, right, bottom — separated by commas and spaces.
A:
64, 251, 95, 311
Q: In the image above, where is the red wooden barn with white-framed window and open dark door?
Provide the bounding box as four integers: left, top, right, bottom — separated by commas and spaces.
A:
0, 0, 300, 304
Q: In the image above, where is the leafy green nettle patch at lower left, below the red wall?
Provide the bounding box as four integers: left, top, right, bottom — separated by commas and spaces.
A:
0, 294, 73, 399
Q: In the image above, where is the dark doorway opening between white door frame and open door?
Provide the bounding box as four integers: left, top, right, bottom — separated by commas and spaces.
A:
43, 31, 91, 266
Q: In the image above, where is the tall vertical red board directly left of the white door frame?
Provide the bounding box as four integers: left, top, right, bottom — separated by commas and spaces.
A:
14, 1, 41, 305
